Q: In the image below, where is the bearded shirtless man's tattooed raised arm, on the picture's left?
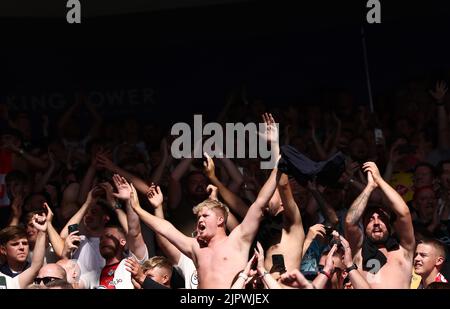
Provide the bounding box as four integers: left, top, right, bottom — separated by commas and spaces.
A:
344, 172, 378, 253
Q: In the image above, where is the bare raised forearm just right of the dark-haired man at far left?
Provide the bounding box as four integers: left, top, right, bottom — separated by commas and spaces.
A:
18, 215, 48, 289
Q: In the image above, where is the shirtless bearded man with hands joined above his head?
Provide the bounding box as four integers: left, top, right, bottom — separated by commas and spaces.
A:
345, 162, 415, 289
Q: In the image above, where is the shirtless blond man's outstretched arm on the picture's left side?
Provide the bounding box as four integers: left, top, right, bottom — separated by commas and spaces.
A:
131, 185, 196, 263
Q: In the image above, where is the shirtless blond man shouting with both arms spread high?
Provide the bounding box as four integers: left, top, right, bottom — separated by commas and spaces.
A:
128, 115, 280, 289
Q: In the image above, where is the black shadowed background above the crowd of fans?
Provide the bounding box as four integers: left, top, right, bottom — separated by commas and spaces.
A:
0, 0, 450, 124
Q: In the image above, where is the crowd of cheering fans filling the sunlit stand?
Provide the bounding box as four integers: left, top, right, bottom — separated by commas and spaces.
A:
0, 77, 450, 289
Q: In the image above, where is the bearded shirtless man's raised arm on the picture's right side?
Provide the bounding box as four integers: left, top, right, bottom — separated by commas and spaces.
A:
363, 162, 416, 254
